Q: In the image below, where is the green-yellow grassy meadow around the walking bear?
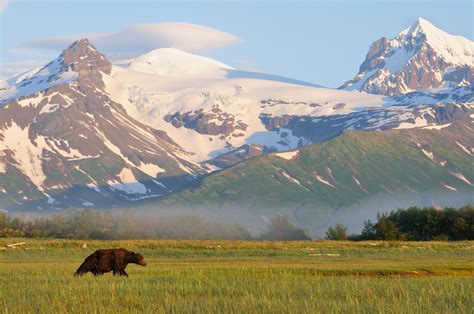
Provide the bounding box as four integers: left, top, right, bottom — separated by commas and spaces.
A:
0, 239, 474, 313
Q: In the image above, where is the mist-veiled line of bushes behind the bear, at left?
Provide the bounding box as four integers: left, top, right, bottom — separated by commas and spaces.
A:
0, 209, 251, 240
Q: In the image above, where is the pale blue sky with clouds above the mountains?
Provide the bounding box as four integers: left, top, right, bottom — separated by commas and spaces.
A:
0, 0, 474, 87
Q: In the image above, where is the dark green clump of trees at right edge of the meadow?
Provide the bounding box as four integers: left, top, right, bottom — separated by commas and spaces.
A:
326, 205, 474, 241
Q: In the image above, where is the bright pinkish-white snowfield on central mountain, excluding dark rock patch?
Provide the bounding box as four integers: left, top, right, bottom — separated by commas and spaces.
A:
103, 53, 391, 162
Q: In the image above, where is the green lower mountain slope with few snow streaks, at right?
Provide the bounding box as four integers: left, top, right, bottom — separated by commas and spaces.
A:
152, 118, 474, 227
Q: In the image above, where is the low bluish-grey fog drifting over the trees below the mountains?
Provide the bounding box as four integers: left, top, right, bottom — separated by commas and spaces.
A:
10, 191, 474, 239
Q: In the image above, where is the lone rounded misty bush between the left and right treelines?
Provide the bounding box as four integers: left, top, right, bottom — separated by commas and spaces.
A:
260, 214, 311, 241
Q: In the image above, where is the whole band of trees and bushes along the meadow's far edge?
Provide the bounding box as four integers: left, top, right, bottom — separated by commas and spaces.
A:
0, 205, 474, 241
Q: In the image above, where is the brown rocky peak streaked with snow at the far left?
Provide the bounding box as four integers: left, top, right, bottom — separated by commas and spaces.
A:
0, 39, 203, 208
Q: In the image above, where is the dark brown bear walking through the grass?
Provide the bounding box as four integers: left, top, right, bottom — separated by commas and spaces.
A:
74, 248, 146, 277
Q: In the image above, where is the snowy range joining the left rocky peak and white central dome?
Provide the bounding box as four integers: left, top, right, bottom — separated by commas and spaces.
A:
0, 30, 474, 208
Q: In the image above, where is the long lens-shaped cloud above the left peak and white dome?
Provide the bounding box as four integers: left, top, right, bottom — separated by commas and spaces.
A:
25, 22, 240, 53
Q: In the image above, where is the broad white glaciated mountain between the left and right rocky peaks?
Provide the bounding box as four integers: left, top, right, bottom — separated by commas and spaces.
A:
104, 49, 473, 164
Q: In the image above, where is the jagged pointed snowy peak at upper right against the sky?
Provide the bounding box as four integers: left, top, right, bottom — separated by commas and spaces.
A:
340, 18, 474, 96
